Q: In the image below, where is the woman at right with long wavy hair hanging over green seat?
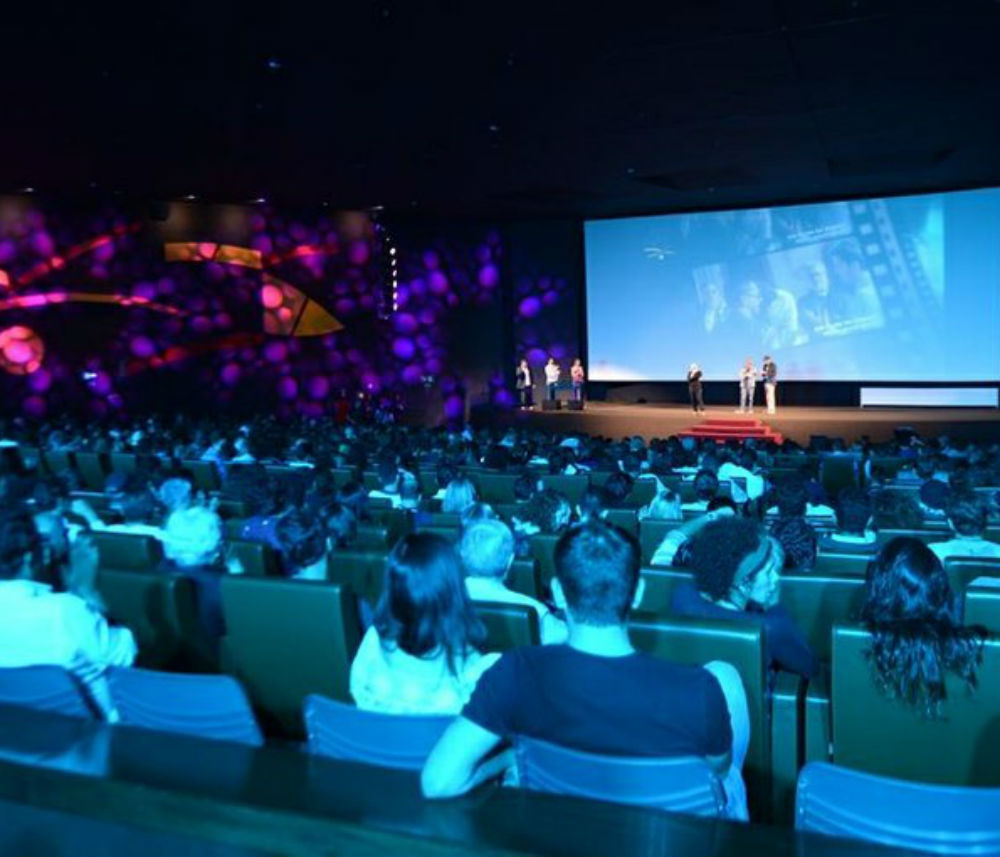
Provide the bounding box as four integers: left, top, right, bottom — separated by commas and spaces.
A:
861, 537, 985, 717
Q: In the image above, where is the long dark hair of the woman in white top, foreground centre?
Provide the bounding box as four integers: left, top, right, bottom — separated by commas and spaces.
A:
374, 532, 485, 673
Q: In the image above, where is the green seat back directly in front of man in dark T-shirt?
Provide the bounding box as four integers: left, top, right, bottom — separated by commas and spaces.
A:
629, 613, 771, 800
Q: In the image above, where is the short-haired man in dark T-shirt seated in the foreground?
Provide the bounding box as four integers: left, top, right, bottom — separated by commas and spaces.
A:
421, 523, 749, 819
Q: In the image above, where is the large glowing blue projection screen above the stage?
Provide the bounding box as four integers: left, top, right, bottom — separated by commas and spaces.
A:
584, 189, 1000, 381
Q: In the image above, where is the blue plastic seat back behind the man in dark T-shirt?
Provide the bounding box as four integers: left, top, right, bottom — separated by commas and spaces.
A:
515, 737, 725, 816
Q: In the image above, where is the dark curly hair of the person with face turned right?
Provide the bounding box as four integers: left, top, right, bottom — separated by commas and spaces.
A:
689, 517, 771, 601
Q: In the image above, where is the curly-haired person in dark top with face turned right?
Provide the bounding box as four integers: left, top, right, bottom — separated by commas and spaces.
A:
670, 518, 819, 678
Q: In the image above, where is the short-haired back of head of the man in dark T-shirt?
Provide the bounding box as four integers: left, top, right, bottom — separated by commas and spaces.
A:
555, 521, 641, 626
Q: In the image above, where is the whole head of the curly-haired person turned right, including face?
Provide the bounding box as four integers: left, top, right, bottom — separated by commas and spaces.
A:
690, 517, 785, 611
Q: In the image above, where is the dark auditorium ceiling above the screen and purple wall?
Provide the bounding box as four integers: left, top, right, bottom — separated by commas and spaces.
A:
0, 0, 1000, 217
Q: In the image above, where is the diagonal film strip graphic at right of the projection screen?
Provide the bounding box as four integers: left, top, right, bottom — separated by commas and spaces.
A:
851, 199, 941, 344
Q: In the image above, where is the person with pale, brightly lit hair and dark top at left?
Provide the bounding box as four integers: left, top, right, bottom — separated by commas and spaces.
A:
163, 506, 233, 645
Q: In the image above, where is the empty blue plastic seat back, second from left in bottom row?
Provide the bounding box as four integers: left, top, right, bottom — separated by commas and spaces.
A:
108, 667, 264, 747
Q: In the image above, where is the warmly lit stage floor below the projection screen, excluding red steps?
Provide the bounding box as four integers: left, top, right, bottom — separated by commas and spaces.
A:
482, 402, 1000, 444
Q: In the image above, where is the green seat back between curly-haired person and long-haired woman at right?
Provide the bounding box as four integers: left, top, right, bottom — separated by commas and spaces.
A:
781, 573, 865, 662
